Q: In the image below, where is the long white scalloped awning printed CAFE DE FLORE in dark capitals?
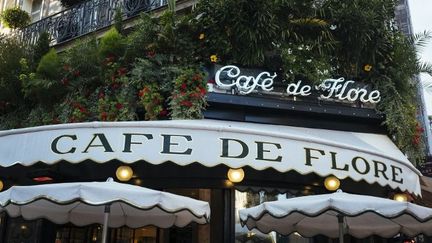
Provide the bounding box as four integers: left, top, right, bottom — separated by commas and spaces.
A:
0, 120, 421, 195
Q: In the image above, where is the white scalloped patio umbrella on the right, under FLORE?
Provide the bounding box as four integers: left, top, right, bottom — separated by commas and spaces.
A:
239, 191, 432, 242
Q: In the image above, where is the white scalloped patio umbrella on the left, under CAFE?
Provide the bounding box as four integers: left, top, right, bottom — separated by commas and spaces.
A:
0, 179, 210, 243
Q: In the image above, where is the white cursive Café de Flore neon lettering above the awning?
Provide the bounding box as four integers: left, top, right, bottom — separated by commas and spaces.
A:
215, 65, 381, 104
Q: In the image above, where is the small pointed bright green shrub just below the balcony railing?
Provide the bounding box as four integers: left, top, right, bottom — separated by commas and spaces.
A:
99, 28, 126, 58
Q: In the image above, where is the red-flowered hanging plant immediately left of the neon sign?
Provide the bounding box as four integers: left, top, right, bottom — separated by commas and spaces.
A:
169, 68, 207, 119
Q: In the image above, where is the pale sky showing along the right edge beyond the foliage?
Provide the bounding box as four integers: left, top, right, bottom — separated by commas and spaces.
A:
408, 0, 432, 116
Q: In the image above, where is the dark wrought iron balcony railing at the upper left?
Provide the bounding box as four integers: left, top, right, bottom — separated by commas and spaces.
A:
21, 0, 167, 45
